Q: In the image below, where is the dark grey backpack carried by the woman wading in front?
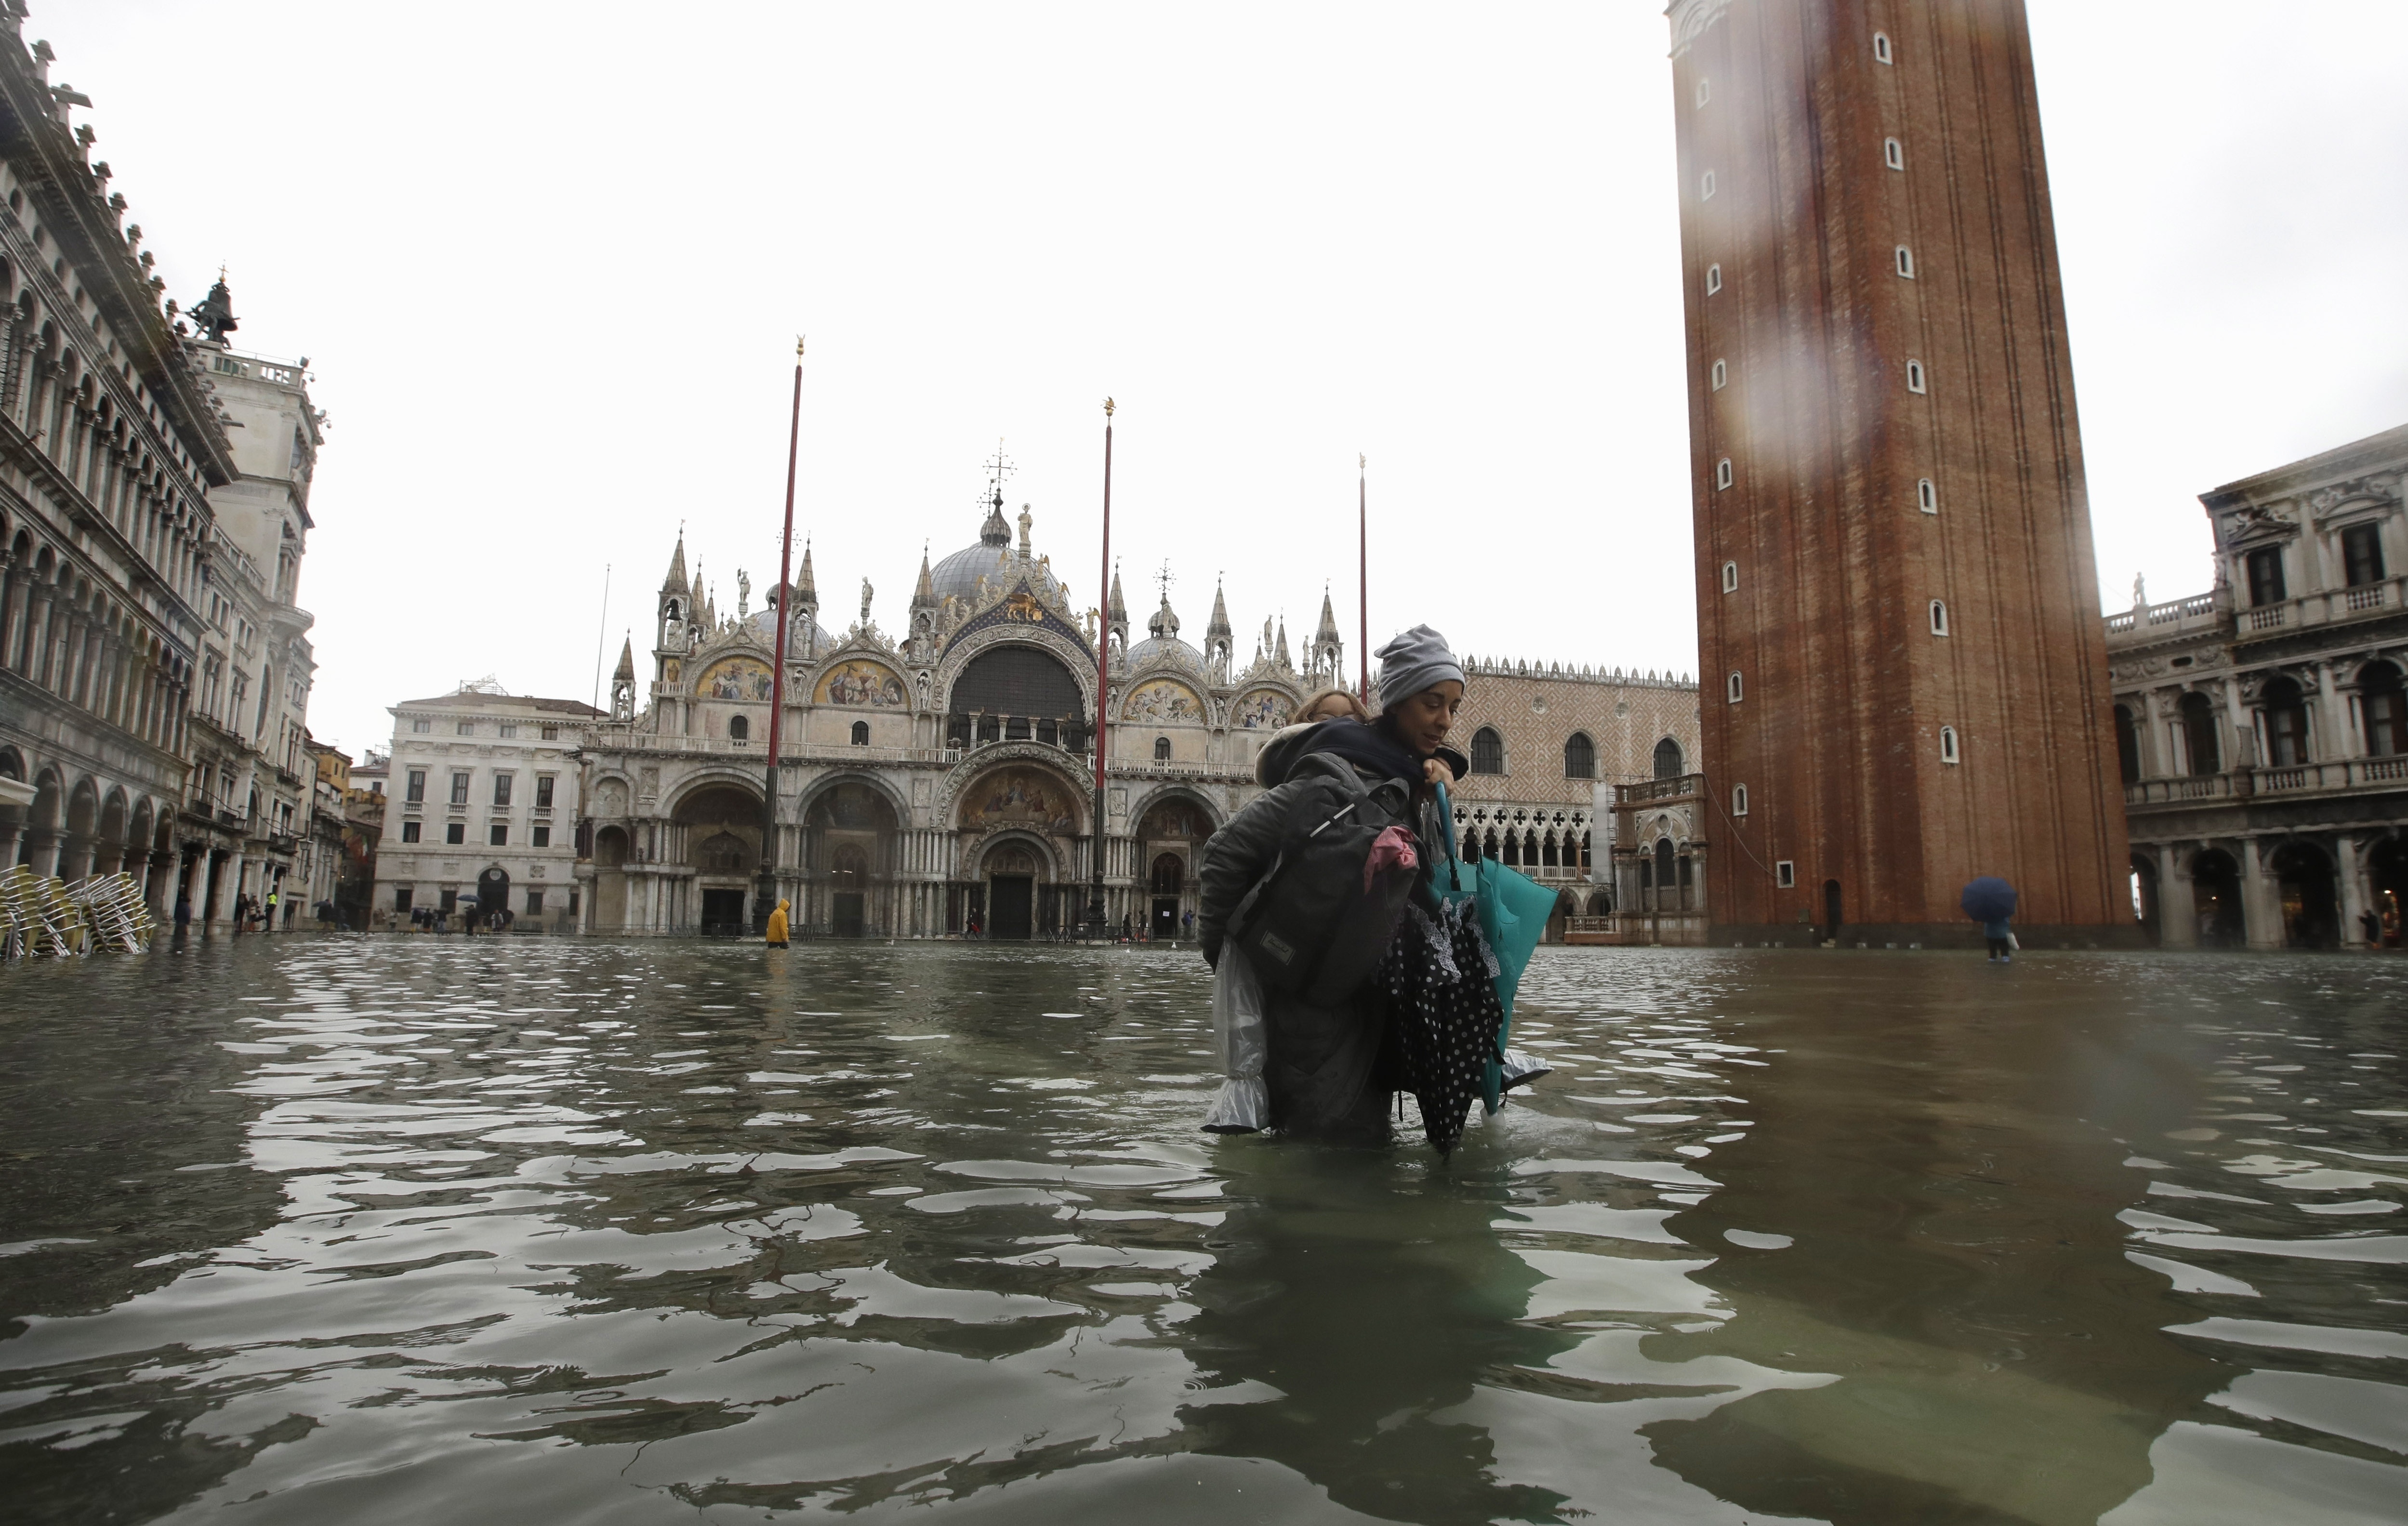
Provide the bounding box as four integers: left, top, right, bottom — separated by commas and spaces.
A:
1228, 775, 1414, 1006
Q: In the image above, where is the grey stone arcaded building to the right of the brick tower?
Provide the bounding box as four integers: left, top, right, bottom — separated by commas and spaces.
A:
2107, 426, 2408, 948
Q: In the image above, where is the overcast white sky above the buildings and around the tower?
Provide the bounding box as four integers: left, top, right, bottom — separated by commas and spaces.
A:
26, 0, 2408, 753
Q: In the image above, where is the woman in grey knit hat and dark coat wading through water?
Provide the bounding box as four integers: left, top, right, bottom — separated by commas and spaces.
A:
1197, 626, 1467, 1139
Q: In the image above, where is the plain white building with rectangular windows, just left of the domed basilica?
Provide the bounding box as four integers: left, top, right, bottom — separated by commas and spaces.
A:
375, 681, 602, 932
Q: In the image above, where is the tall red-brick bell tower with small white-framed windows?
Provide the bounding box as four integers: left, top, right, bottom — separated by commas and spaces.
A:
1667, 0, 2138, 948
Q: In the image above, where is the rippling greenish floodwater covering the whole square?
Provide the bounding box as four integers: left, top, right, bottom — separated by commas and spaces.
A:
0, 939, 2408, 1526
